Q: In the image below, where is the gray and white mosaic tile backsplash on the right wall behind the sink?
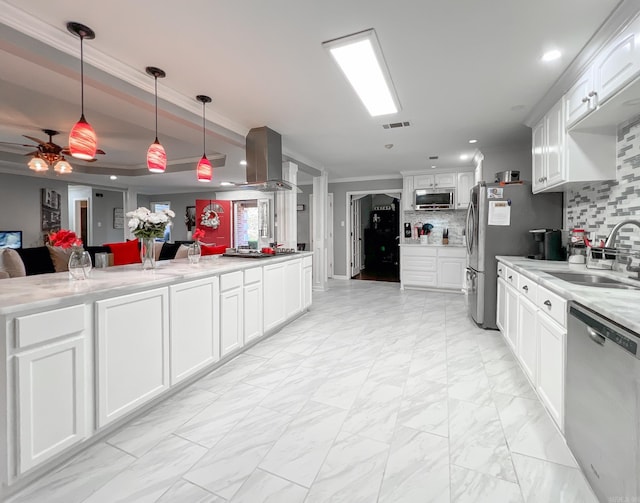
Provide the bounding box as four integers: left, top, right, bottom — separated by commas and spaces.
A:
565, 116, 640, 252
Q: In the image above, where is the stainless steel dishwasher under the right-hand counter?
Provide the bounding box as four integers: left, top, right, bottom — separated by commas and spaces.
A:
565, 303, 640, 503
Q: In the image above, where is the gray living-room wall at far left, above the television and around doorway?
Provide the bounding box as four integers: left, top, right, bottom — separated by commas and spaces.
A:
0, 172, 69, 248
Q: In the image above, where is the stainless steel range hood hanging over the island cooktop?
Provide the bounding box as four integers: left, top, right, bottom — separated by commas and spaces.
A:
240, 126, 297, 192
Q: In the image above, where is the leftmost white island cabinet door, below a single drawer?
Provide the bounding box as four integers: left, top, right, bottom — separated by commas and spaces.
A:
16, 333, 89, 473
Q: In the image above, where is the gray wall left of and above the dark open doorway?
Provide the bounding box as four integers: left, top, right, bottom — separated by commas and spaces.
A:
329, 178, 402, 276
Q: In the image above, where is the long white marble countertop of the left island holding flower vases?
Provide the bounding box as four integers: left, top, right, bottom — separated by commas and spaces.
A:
0, 252, 313, 315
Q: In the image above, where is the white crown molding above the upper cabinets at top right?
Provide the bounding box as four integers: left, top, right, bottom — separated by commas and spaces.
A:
524, 0, 640, 128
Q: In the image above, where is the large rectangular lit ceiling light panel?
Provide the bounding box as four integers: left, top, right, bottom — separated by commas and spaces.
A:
322, 29, 400, 117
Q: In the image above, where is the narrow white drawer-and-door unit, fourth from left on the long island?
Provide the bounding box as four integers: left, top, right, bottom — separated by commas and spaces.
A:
220, 271, 244, 357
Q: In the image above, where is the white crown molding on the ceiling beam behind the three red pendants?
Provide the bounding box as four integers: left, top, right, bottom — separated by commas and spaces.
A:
0, 0, 249, 137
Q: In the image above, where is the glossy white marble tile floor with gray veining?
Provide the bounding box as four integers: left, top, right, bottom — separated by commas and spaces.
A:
11, 281, 597, 503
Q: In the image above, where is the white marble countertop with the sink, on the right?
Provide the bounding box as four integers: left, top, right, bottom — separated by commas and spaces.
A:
496, 256, 640, 333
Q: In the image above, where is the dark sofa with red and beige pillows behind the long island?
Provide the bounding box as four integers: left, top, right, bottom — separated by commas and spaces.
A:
0, 239, 226, 279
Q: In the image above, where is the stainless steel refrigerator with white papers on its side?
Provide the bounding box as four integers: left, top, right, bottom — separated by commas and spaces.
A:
465, 182, 562, 329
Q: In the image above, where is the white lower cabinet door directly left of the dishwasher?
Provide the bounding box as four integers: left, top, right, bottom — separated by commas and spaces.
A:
536, 313, 567, 430
